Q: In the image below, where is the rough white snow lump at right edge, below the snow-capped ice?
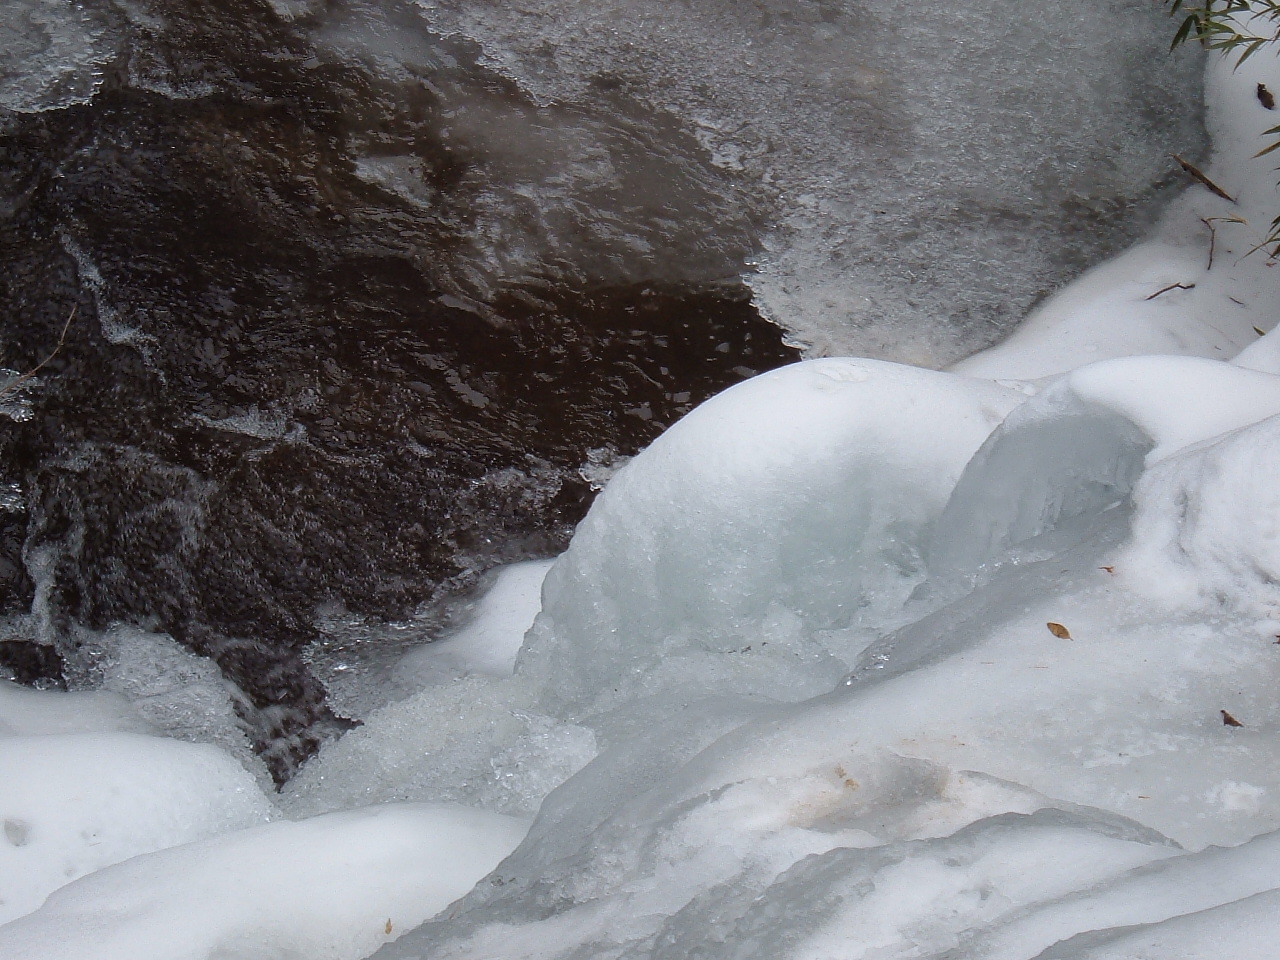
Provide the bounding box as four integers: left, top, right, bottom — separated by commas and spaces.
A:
1117, 416, 1280, 617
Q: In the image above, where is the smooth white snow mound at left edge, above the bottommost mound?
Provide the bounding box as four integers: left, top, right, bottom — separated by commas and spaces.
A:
0, 733, 271, 926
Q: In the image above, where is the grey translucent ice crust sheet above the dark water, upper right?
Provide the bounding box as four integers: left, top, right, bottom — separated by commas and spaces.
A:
404, 0, 1198, 365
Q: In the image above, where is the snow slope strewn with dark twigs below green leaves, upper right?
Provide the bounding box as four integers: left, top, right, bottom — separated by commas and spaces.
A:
955, 27, 1280, 379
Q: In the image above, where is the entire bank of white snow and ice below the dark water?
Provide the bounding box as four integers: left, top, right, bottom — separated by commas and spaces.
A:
0, 5, 1280, 960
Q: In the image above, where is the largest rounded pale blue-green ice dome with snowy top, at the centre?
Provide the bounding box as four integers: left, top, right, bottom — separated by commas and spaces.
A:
517, 358, 1025, 708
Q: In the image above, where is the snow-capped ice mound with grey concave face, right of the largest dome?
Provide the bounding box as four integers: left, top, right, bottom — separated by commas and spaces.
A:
929, 356, 1280, 577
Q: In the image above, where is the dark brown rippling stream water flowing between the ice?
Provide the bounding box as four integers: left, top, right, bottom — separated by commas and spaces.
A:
0, 0, 1187, 778
